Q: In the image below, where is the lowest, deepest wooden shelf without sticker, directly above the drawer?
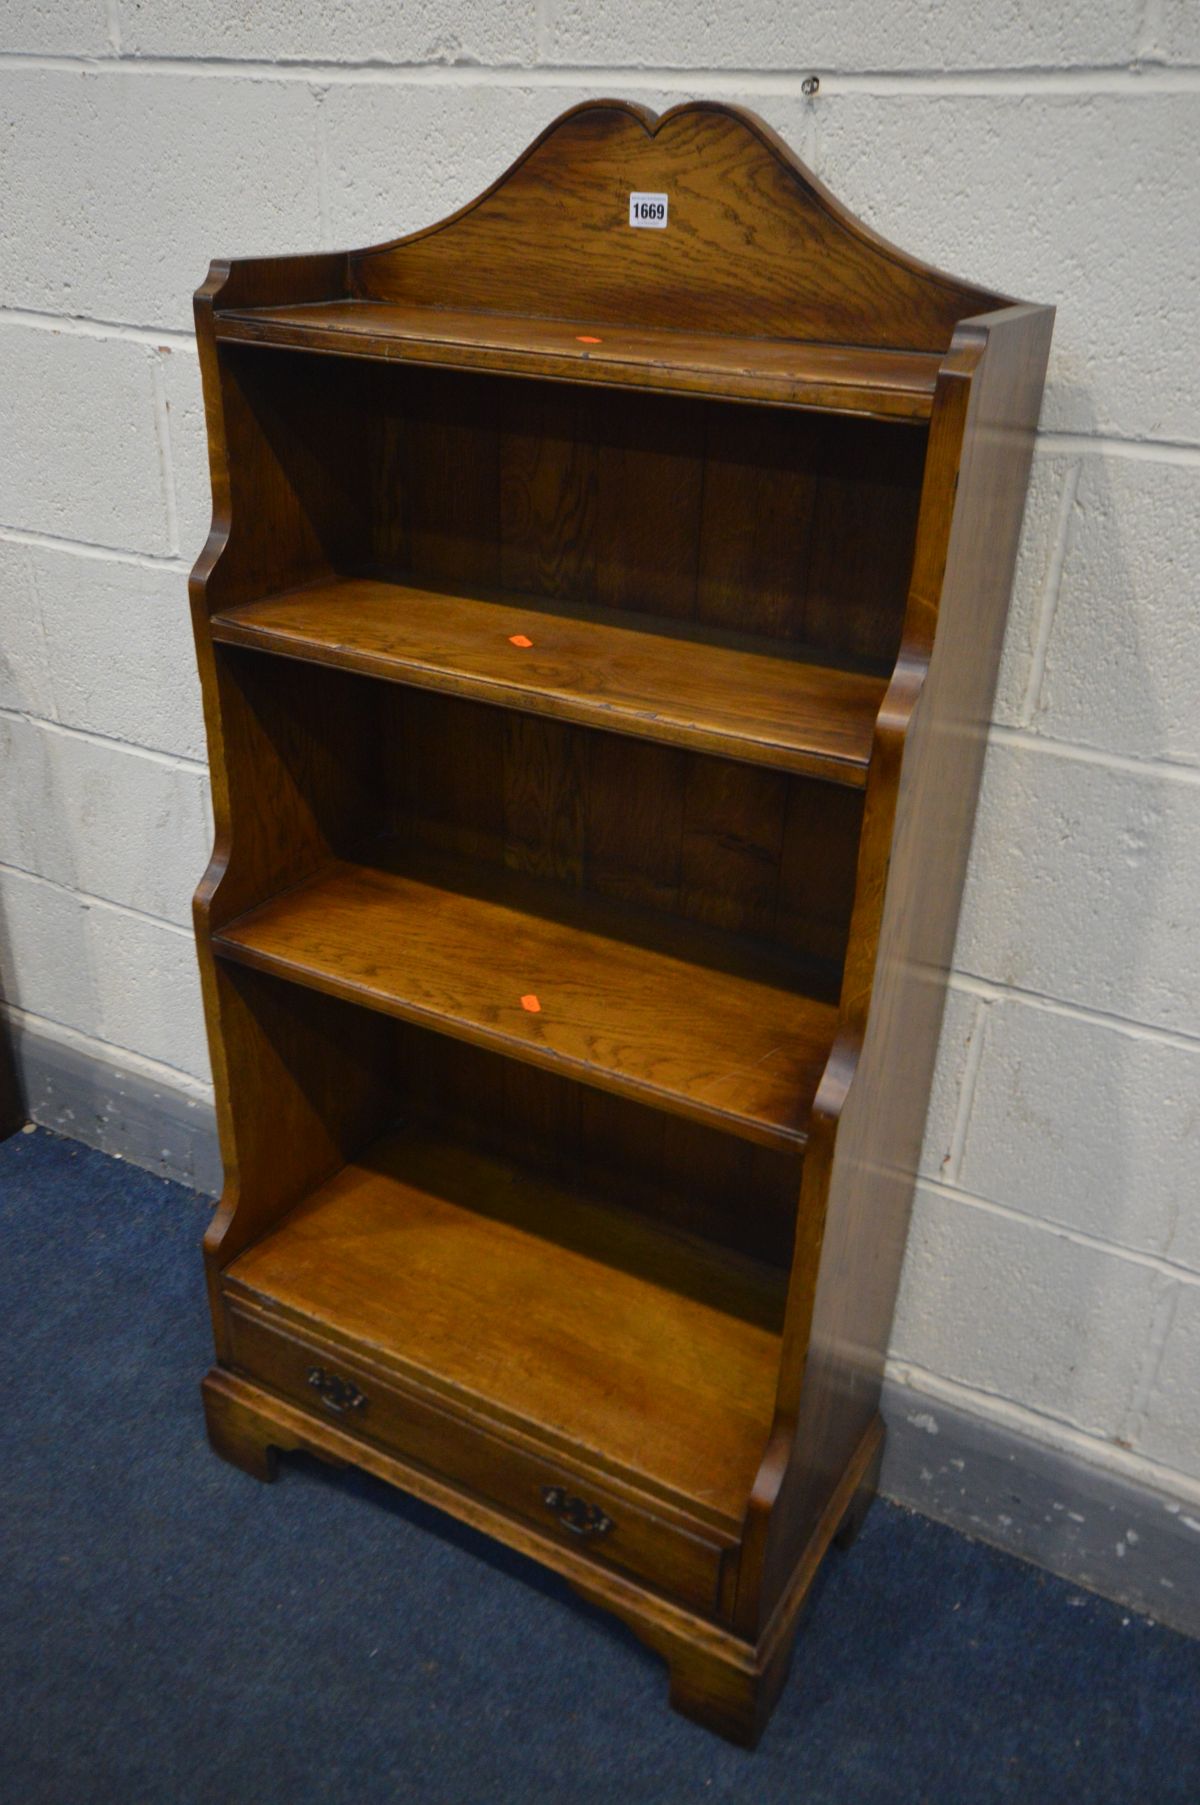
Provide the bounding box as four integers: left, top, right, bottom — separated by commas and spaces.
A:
226, 1130, 783, 1531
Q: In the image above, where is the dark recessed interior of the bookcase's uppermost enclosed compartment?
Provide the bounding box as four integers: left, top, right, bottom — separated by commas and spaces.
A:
201, 347, 926, 657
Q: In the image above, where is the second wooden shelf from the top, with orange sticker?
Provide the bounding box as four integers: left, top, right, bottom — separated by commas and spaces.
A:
213, 578, 886, 789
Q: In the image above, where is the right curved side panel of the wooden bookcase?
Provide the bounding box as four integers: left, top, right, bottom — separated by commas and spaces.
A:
736, 307, 1054, 1637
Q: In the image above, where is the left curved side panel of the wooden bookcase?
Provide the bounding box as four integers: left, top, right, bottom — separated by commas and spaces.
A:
189, 258, 390, 1354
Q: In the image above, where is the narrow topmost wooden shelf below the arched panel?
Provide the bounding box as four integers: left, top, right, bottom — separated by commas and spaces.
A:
215, 300, 942, 421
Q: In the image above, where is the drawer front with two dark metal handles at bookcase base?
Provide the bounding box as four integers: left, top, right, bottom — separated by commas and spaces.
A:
226, 1300, 722, 1615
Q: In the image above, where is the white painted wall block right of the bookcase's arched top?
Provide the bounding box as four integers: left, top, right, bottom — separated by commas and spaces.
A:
819, 94, 1200, 444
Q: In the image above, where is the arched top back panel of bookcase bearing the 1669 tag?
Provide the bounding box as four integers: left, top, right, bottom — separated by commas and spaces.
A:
348, 101, 1007, 352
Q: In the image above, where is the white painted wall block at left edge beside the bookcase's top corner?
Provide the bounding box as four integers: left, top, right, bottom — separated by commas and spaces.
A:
0, 70, 319, 330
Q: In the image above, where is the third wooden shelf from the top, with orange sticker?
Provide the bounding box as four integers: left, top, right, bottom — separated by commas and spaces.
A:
215, 845, 837, 1148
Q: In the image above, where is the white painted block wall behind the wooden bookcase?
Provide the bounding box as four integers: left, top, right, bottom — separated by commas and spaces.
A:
0, 10, 1200, 1507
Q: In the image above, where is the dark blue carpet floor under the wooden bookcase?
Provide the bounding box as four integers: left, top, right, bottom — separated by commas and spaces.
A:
0, 1132, 1200, 1805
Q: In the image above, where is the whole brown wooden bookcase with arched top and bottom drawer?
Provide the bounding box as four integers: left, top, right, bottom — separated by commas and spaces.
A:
191, 101, 1052, 1742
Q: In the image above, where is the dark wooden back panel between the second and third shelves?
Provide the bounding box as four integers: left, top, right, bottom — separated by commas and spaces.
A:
384, 689, 863, 960
